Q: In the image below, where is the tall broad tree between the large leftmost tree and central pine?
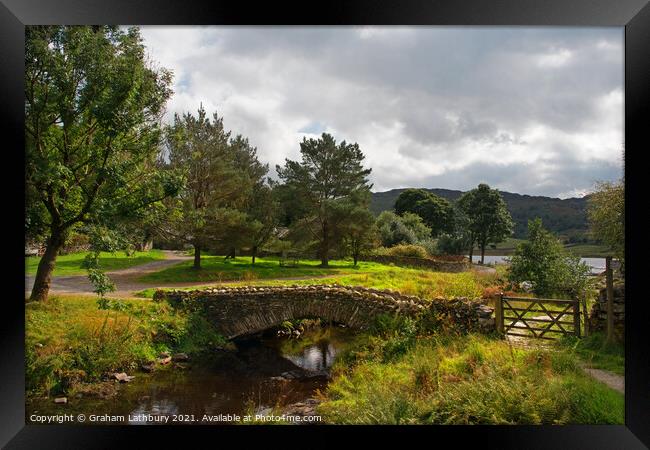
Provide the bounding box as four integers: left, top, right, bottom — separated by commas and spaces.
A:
162, 106, 268, 269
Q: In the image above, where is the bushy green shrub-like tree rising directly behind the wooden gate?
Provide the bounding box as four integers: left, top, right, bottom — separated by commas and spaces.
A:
508, 218, 591, 295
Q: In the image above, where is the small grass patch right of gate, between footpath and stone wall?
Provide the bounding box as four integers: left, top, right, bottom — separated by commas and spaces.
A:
560, 333, 625, 375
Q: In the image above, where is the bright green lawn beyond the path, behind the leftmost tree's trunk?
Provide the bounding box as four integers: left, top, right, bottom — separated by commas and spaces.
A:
25, 250, 165, 276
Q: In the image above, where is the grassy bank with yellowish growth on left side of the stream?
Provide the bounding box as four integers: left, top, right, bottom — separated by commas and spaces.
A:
25, 295, 223, 396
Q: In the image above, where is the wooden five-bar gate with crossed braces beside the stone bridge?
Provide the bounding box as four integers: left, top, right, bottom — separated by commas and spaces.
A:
495, 294, 580, 340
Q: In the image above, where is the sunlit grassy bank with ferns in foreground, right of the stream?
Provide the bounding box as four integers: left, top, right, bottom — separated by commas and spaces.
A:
318, 323, 624, 424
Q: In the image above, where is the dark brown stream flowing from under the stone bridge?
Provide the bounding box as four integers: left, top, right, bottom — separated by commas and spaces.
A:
26, 326, 353, 425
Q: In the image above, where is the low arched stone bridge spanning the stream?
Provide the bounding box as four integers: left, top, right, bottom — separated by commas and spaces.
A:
154, 285, 494, 339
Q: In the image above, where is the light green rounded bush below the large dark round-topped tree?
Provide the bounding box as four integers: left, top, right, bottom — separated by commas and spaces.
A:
375, 211, 431, 247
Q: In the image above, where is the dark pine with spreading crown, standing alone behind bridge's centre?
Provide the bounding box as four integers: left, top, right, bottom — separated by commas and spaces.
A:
276, 133, 372, 267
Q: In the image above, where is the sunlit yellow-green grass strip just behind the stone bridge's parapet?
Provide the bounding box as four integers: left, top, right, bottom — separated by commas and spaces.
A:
136, 263, 501, 298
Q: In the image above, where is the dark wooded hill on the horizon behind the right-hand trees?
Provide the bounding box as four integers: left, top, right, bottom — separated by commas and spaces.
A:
370, 189, 588, 242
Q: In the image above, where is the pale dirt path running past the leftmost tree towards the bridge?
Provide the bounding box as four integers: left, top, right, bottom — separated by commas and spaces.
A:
25, 250, 364, 298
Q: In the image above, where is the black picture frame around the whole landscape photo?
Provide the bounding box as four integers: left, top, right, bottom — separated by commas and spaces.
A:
0, 0, 650, 449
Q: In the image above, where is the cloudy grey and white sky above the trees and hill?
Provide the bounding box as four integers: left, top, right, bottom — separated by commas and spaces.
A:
142, 27, 624, 198
